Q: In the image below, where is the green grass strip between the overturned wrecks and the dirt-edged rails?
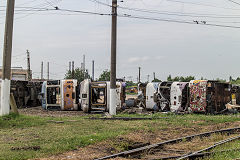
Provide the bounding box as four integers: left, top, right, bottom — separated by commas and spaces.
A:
0, 113, 239, 160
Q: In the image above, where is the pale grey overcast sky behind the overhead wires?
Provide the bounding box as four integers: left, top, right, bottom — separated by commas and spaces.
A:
0, 0, 240, 81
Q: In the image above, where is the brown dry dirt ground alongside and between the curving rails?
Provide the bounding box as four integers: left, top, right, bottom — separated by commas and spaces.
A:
34, 122, 240, 160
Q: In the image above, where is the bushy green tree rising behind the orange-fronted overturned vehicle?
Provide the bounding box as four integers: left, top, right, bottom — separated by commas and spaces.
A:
64, 68, 90, 82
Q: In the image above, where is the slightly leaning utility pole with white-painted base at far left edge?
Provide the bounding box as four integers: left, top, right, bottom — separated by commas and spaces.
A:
0, 0, 15, 116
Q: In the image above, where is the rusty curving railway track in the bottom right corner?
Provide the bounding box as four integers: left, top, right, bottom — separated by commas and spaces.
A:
95, 127, 240, 160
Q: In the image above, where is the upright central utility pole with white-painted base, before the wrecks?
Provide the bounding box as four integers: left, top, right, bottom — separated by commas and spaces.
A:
109, 0, 117, 115
